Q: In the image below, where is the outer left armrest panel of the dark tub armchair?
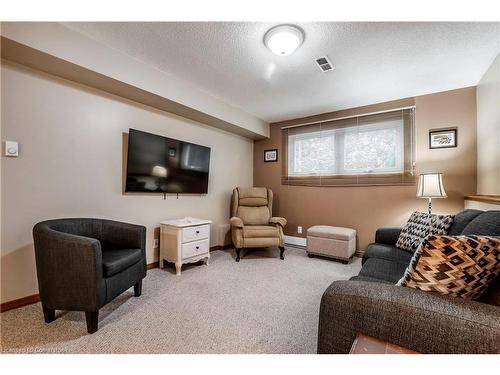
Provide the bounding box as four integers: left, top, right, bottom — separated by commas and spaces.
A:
33, 226, 105, 311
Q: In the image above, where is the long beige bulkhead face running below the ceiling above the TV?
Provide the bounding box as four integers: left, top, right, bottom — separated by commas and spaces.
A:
1, 22, 269, 137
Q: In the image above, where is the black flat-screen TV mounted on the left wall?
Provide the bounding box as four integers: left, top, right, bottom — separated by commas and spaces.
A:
125, 129, 210, 194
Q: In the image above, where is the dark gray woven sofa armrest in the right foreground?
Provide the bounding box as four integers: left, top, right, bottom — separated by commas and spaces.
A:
318, 281, 500, 353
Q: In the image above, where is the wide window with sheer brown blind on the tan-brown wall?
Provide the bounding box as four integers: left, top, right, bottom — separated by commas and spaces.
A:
283, 108, 413, 185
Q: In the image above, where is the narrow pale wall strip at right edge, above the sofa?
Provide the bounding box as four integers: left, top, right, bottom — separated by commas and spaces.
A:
477, 54, 500, 195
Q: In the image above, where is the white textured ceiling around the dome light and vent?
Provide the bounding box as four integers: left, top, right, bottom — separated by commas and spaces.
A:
61, 22, 500, 122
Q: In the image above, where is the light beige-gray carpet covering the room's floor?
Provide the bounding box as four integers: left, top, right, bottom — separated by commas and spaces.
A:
1, 248, 361, 353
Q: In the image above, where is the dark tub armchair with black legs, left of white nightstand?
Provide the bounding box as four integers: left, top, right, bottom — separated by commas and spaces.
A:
33, 218, 146, 333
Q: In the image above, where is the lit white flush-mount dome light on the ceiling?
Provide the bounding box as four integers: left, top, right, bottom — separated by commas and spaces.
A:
264, 25, 304, 56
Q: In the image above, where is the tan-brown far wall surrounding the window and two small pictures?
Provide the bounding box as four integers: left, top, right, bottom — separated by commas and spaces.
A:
254, 87, 476, 254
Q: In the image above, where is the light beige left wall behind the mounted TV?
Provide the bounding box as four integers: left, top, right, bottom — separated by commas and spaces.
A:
1, 64, 253, 302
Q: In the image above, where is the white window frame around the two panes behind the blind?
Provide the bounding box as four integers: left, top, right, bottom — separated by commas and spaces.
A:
287, 120, 405, 177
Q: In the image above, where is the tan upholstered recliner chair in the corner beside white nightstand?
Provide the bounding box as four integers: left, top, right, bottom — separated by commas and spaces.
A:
230, 187, 286, 262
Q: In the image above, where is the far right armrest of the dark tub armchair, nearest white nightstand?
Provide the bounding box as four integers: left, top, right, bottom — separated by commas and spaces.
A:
102, 220, 146, 256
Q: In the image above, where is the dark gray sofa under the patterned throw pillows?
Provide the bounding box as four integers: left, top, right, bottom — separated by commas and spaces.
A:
318, 210, 500, 353
